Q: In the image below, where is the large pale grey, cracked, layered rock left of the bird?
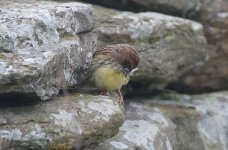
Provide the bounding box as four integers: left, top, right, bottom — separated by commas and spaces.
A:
0, 2, 96, 100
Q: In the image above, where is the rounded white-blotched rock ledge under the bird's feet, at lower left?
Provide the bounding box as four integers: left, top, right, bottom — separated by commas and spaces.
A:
0, 93, 124, 150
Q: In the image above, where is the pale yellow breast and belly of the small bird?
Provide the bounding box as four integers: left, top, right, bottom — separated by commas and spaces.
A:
94, 65, 129, 90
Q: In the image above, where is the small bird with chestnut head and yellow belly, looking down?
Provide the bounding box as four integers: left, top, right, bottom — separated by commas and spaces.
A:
92, 44, 139, 105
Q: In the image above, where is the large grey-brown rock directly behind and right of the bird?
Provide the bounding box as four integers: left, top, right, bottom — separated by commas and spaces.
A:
94, 6, 206, 88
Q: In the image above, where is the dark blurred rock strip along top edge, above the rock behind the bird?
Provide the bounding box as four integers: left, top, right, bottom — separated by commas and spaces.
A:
78, 0, 202, 18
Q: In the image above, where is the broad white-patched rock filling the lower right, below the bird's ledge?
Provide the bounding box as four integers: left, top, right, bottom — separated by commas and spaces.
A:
88, 91, 228, 150
